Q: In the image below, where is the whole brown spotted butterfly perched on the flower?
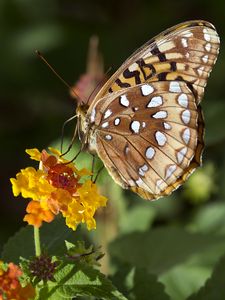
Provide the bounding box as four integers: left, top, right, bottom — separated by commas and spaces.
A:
77, 20, 219, 200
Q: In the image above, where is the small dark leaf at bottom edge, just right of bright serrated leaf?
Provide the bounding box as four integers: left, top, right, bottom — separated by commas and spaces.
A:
129, 268, 170, 300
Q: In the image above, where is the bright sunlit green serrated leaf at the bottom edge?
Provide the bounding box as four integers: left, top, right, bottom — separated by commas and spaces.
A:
37, 264, 127, 300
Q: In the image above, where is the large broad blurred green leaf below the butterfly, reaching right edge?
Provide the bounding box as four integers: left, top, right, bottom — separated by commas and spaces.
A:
109, 227, 224, 273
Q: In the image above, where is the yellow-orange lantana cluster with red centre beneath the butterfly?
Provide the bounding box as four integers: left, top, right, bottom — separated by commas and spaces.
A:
10, 148, 107, 230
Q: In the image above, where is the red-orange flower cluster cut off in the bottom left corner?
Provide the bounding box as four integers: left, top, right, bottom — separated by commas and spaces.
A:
0, 262, 35, 300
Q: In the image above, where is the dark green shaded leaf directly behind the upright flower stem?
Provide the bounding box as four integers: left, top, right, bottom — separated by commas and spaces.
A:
2, 217, 89, 263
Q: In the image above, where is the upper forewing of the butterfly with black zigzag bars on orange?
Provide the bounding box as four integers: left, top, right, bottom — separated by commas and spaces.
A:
96, 20, 219, 103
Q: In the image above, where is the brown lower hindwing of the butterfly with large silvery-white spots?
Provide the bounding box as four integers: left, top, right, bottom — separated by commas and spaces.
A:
87, 81, 203, 199
